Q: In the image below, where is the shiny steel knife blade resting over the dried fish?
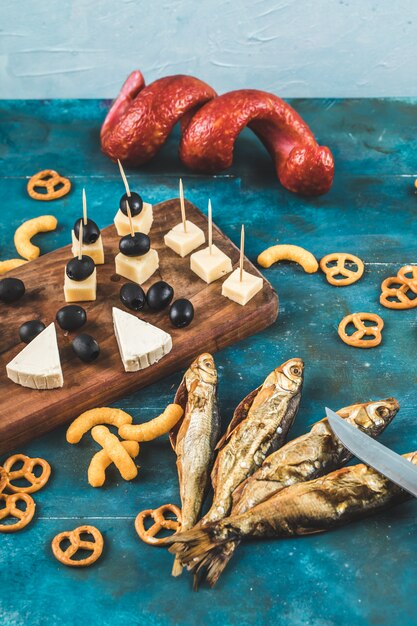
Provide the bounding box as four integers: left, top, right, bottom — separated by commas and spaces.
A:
326, 407, 417, 498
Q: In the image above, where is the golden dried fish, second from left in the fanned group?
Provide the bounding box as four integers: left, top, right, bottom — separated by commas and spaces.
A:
201, 359, 304, 524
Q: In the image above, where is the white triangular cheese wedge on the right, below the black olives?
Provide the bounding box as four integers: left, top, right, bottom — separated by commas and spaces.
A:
113, 307, 172, 372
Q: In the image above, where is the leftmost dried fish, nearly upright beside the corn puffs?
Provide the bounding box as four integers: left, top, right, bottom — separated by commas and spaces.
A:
170, 353, 220, 575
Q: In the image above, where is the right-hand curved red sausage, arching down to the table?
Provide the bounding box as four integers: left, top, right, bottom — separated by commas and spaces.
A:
180, 89, 334, 195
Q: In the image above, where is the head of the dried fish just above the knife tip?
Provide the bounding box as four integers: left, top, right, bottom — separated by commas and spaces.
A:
339, 398, 400, 435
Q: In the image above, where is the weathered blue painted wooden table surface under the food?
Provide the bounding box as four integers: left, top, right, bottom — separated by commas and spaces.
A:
0, 100, 417, 626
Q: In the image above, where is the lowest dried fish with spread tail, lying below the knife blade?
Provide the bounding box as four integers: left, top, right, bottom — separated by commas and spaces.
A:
170, 452, 417, 585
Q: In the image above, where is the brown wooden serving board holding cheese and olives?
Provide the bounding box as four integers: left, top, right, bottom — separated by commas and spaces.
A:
0, 199, 278, 453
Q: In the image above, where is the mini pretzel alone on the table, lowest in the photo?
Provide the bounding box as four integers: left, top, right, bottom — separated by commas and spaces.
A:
52, 526, 104, 567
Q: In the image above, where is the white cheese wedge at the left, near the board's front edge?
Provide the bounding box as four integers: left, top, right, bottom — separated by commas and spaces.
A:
6, 322, 64, 389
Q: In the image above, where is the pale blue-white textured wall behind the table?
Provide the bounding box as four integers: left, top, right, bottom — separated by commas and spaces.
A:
0, 0, 417, 98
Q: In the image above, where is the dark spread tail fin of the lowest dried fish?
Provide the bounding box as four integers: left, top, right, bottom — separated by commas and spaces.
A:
169, 524, 240, 589
